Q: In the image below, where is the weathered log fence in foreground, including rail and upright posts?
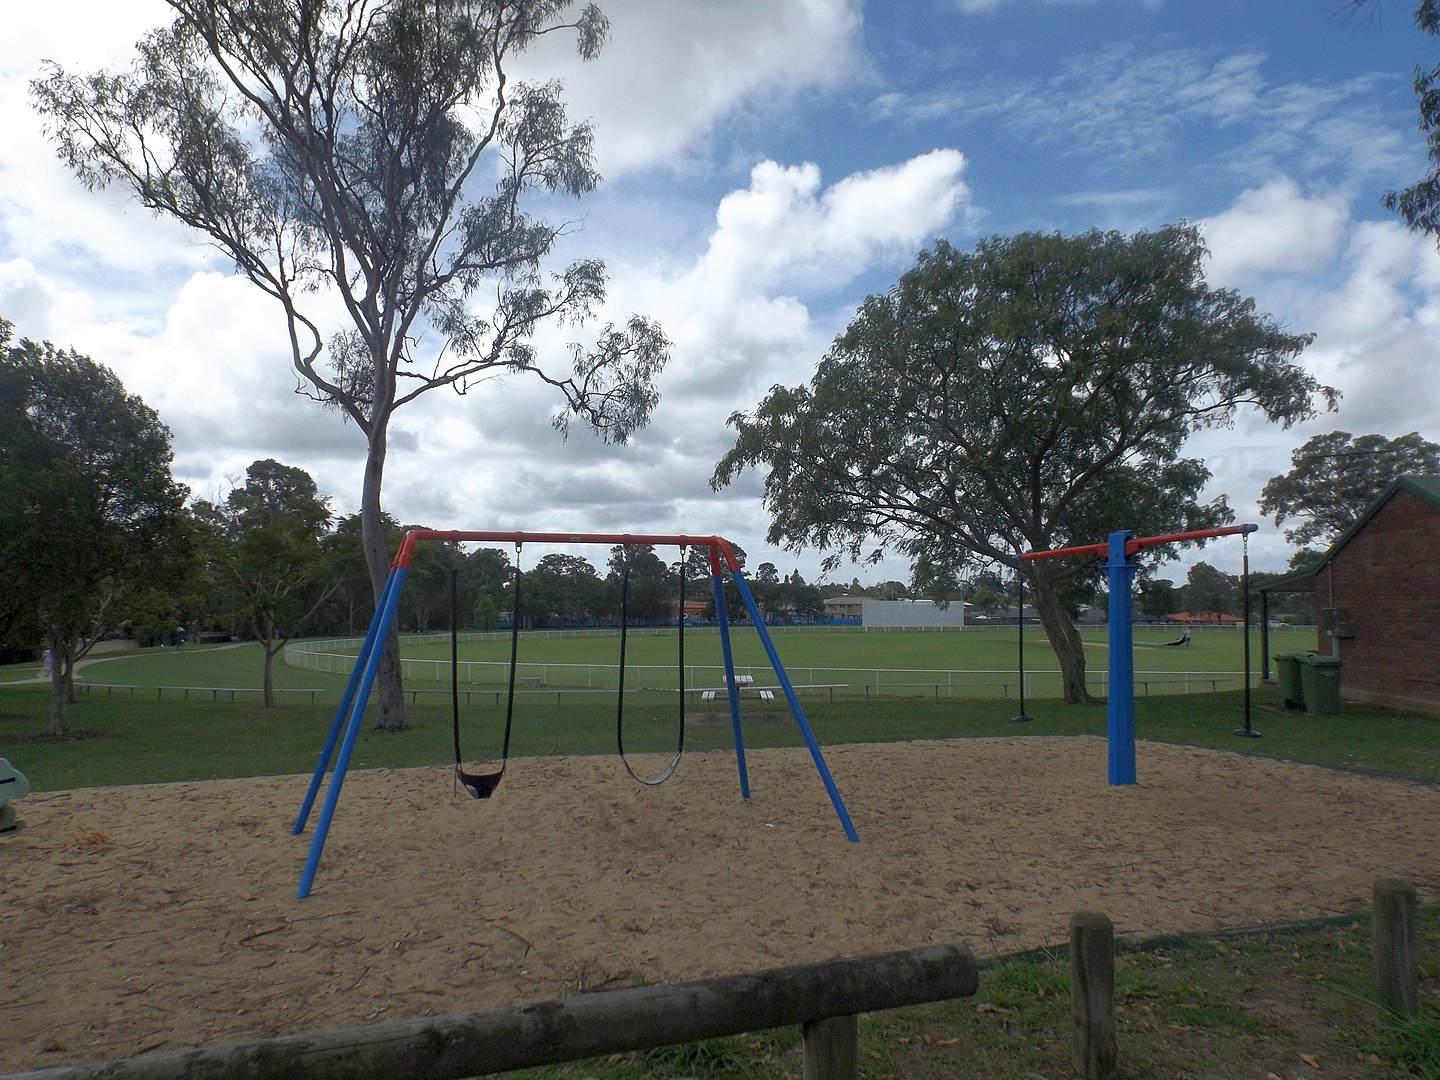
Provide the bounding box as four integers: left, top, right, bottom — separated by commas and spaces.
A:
0, 874, 1420, 1080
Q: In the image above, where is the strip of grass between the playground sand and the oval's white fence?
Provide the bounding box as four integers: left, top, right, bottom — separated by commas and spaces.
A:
0, 635, 1440, 791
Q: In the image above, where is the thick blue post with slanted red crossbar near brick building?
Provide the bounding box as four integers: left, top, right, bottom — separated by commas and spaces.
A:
1018, 524, 1260, 788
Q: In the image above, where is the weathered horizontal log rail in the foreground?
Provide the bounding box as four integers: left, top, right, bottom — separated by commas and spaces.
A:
8, 945, 979, 1080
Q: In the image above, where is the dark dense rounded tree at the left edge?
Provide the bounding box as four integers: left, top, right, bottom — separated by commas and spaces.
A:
0, 320, 194, 736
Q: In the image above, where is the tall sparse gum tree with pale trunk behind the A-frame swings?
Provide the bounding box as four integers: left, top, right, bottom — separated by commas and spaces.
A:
30, 0, 668, 727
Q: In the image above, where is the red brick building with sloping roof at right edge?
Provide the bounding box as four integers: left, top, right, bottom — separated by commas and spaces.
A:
1264, 477, 1440, 714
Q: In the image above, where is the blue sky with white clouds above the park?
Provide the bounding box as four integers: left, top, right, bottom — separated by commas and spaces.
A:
0, 0, 1440, 593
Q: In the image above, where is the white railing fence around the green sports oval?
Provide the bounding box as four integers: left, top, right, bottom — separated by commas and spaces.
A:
285, 628, 1244, 698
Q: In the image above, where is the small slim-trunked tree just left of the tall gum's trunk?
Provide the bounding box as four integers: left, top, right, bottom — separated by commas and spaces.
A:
196, 458, 338, 707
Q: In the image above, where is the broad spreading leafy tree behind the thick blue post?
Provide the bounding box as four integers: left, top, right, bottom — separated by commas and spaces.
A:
711, 225, 1335, 701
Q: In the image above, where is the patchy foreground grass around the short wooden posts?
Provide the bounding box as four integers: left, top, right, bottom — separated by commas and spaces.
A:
513, 906, 1440, 1080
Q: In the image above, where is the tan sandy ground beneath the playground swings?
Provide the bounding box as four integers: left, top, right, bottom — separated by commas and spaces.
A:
0, 737, 1440, 1071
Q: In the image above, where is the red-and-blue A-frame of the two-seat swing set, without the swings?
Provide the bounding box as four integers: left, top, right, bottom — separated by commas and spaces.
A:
291, 528, 860, 900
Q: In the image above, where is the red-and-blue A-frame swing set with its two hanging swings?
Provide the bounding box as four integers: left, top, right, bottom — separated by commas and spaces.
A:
291, 528, 860, 900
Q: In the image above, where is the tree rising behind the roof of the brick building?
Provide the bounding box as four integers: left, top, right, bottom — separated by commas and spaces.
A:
1260, 431, 1440, 547
